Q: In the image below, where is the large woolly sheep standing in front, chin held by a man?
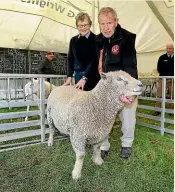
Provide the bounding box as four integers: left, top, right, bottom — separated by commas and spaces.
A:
47, 71, 142, 180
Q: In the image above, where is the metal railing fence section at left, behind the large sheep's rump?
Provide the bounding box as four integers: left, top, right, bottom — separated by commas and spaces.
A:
0, 74, 66, 151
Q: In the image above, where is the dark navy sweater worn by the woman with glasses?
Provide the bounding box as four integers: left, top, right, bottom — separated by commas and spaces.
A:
67, 32, 100, 91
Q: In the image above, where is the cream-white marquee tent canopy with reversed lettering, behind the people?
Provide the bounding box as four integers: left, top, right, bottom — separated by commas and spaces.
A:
0, 0, 174, 72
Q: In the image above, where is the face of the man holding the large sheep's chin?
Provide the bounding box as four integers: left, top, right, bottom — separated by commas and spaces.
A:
98, 13, 118, 38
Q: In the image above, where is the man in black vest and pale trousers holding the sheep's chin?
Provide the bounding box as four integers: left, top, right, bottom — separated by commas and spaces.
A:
97, 7, 138, 159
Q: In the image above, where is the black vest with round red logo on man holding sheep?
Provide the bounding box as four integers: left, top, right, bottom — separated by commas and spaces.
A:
96, 24, 138, 79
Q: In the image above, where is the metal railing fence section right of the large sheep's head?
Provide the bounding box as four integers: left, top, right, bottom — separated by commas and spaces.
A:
137, 77, 174, 135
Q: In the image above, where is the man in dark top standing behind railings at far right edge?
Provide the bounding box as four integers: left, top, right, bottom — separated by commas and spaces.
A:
153, 43, 174, 116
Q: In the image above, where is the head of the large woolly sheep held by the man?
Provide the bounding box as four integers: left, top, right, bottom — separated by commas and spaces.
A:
101, 71, 142, 98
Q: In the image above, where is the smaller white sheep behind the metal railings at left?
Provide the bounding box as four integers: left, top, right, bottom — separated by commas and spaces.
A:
24, 78, 56, 121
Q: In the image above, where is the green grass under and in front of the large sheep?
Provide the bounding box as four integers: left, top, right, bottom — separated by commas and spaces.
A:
0, 124, 174, 192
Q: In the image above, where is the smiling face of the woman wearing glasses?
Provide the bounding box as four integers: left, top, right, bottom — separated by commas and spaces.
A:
77, 18, 91, 36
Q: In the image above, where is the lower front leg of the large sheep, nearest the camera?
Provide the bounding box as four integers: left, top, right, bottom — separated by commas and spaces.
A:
72, 154, 85, 180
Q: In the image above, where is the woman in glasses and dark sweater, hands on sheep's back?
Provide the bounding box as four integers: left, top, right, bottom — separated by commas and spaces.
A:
64, 13, 100, 91
